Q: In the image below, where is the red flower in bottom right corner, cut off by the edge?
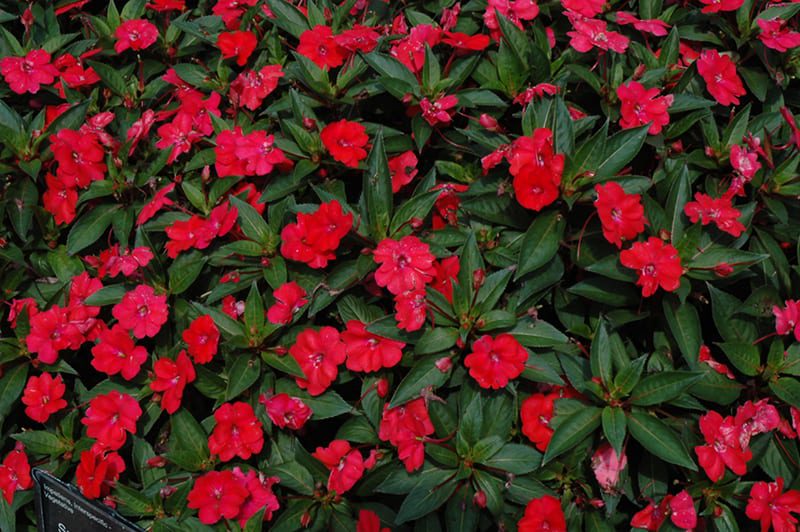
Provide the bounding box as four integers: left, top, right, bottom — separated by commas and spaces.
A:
745, 477, 800, 532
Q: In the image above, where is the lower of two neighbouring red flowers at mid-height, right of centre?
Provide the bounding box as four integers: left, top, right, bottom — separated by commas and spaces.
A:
619, 236, 683, 297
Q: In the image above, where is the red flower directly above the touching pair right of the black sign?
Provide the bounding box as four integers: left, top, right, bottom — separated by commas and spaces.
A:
208, 402, 264, 462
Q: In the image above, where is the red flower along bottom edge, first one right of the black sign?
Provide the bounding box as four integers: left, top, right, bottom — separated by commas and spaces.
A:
187, 471, 250, 525
